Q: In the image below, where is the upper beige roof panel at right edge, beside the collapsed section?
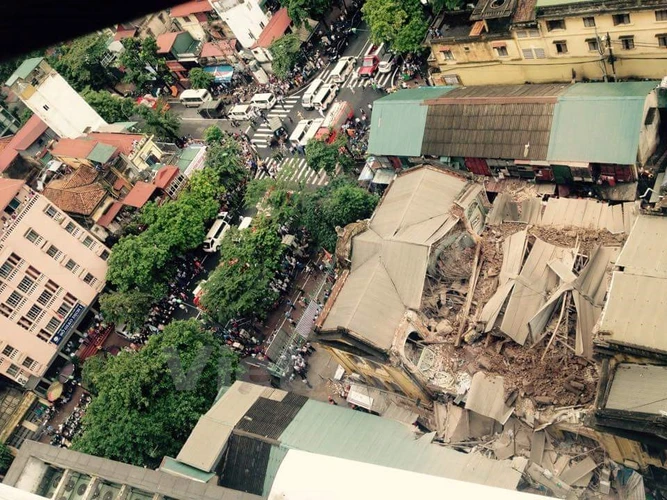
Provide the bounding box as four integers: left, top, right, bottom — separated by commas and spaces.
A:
616, 215, 667, 278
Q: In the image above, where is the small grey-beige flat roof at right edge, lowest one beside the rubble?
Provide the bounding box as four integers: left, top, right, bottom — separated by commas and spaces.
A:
604, 363, 667, 415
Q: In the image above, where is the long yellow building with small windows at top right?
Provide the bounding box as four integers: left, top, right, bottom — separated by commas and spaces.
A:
426, 0, 667, 85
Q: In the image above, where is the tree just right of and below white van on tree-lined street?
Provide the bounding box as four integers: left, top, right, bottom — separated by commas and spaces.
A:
201, 217, 285, 324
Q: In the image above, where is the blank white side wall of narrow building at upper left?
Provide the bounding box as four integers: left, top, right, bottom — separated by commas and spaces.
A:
24, 72, 107, 139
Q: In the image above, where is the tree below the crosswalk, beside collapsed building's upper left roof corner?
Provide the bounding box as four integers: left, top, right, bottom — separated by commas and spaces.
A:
298, 178, 379, 252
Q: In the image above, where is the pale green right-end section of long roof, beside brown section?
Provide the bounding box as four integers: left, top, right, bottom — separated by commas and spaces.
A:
547, 82, 658, 165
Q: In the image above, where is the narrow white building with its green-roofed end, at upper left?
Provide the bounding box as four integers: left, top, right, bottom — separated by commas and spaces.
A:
7, 57, 107, 139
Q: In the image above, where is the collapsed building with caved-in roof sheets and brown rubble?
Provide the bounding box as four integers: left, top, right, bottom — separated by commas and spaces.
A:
314, 167, 667, 498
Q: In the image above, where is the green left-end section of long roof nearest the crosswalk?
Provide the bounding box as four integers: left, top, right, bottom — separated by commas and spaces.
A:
368, 87, 455, 156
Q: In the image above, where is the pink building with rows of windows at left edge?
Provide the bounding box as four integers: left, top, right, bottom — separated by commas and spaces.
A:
0, 179, 109, 394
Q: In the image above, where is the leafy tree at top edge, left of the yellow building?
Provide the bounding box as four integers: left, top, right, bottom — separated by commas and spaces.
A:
361, 0, 428, 53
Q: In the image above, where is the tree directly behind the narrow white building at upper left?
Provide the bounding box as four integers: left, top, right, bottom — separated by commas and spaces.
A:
49, 33, 113, 92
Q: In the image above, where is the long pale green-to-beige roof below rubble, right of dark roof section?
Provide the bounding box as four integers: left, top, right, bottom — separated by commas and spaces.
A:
280, 400, 521, 489
